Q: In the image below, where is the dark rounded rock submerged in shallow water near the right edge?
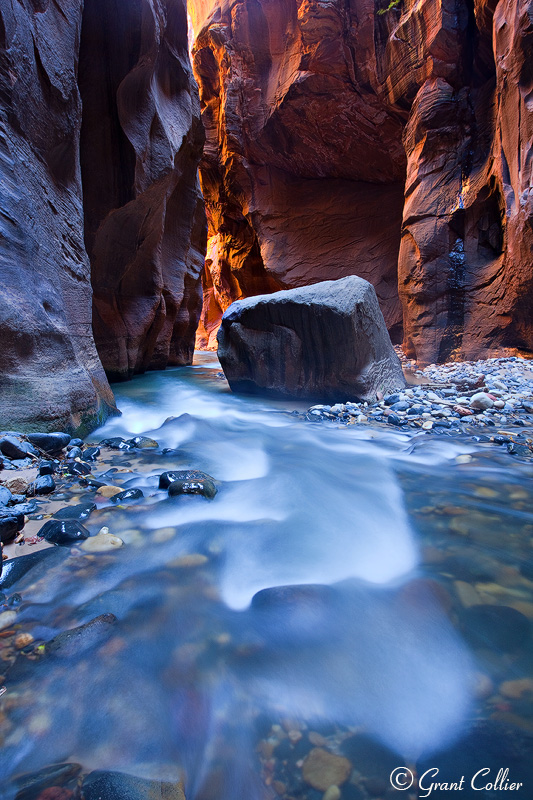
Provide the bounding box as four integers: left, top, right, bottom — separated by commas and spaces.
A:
461, 605, 531, 652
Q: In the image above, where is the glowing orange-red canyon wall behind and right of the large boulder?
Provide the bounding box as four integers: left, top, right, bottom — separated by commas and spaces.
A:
190, 0, 533, 363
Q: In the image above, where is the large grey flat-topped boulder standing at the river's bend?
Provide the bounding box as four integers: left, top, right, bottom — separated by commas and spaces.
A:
217, 276, 405, 401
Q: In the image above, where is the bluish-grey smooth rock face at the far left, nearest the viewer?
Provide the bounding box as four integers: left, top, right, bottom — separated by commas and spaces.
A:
0, 0, 115, 431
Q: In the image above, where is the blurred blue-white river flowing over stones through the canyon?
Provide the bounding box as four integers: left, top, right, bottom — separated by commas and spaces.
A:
0, 355, 533, 800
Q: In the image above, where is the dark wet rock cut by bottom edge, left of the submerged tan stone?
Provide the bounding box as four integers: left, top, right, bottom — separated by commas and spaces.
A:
81, 771, 185, 800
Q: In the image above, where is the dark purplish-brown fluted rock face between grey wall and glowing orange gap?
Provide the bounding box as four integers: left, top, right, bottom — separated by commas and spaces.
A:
79, 0, 206, 380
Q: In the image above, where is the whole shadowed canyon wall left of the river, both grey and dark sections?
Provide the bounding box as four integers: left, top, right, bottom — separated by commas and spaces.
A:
0, 0, 206, 432
